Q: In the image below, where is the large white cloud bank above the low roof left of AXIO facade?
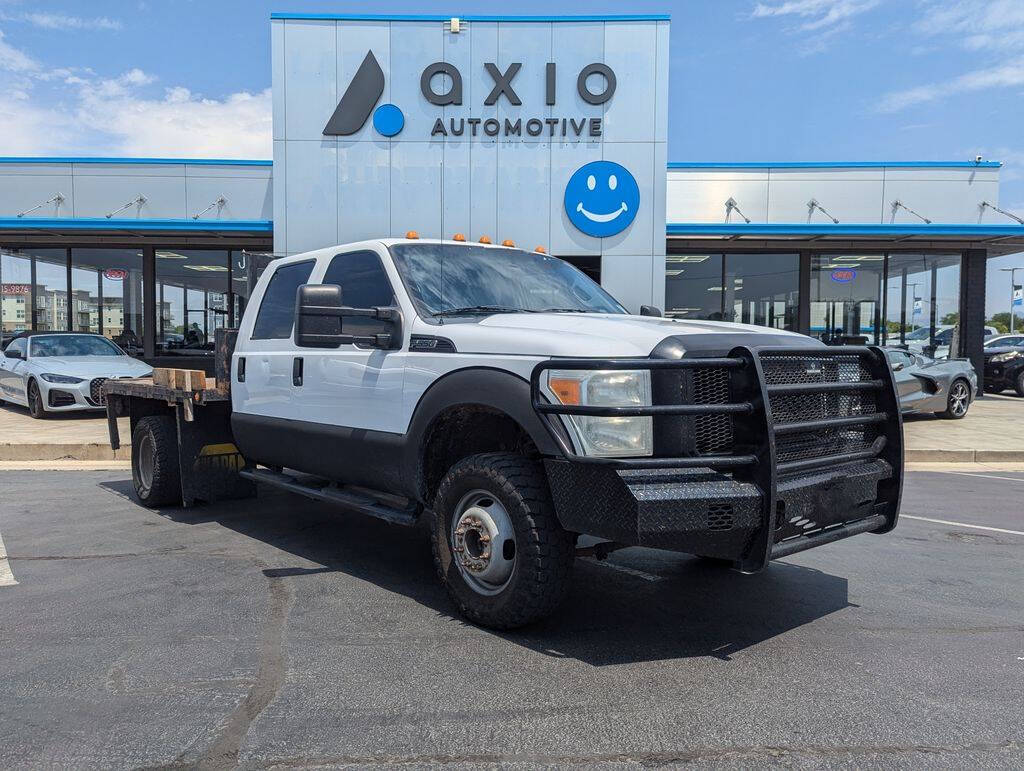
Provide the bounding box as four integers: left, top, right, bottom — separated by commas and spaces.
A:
0, 25, 271, 158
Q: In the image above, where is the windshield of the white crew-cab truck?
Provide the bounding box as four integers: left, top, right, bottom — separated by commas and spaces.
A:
391, 244, 626, 318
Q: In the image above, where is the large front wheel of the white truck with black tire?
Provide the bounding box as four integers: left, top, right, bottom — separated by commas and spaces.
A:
432, 453, 575, 630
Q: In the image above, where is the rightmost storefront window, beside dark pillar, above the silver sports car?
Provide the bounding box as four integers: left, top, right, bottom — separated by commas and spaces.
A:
884, 254, 961, 358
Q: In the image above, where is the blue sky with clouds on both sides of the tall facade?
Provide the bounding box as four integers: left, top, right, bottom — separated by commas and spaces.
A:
0, 0, 1024, 311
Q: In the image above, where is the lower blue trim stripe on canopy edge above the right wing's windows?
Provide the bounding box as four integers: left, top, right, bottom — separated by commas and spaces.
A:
666, 222, 1024, 239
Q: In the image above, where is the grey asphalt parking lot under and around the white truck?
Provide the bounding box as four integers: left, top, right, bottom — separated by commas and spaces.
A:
0, 471, 1024, 768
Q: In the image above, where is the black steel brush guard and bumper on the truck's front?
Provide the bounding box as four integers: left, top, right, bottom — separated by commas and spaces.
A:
530, 346, 903, 572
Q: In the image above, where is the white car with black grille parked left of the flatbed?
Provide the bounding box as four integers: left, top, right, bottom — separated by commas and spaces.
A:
0, 332, 153, 418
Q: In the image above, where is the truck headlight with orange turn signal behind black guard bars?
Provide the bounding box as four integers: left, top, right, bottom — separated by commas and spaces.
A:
545, 370, 654, 458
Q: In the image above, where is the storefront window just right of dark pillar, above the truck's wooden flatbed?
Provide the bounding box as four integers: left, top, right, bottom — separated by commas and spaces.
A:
156, 249, 231, 355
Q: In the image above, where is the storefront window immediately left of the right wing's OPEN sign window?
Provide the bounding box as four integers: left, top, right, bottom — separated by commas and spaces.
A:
722, 254, 800, 330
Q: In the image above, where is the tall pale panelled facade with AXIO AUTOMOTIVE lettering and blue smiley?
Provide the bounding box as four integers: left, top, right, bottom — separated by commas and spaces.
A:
271, 14, 669, 309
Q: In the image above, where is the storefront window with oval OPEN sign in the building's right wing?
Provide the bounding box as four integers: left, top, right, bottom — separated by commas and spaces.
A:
810, 254, 886, 345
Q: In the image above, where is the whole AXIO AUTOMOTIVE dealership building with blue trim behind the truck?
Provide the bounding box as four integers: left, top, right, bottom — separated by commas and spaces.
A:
0, 13, 1024, 384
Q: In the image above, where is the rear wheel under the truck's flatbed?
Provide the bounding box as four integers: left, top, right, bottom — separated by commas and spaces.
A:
131, 415, 181, 509
